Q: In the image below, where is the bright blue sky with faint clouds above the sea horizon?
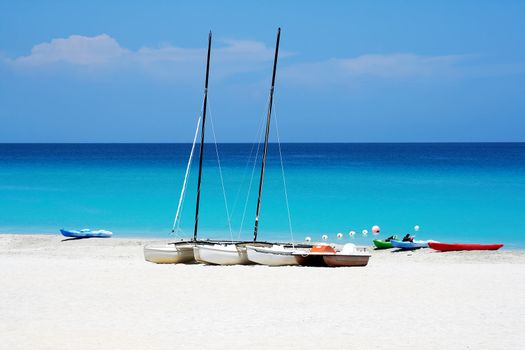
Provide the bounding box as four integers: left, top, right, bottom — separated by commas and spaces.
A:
0, 0, 525, 142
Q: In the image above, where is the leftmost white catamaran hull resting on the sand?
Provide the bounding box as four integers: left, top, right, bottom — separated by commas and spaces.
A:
144, 243, 195, 264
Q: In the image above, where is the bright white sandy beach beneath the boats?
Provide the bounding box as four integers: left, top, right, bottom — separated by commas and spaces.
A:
0, 234, 525, 349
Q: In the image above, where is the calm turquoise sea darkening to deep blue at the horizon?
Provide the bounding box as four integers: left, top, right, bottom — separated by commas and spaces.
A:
0, 143, 525, 248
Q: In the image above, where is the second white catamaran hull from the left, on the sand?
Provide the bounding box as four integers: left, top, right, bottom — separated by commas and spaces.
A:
193, 244, 251, 265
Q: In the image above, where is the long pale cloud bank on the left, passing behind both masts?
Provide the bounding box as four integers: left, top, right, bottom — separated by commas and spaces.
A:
0, 34, 291, 80
